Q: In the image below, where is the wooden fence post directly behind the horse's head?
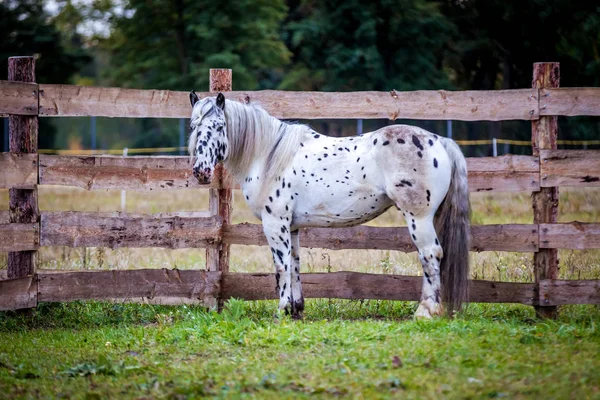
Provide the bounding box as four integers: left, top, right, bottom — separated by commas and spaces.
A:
206, 69, 233, 309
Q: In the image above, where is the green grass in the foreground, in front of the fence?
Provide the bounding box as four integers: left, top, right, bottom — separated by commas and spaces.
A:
0, 300, 600, 399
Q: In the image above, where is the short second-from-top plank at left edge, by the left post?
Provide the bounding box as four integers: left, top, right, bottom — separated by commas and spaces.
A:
0, 153, 38, 189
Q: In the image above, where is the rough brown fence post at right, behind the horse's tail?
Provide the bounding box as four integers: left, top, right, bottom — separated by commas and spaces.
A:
531, 63, 560, 318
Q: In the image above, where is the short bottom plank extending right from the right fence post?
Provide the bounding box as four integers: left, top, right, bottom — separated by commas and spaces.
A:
540, 279, 600, 306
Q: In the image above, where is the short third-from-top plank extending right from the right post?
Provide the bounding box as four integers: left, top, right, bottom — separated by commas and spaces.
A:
540, 222, 600, 250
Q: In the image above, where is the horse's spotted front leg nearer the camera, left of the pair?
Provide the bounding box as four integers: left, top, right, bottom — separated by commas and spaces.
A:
262, 214, 294, 314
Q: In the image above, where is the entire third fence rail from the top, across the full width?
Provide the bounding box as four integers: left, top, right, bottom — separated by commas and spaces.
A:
0, 211, 600, 252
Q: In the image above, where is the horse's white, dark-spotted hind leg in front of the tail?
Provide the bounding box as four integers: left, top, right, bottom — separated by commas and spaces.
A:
404, 213, 444, 318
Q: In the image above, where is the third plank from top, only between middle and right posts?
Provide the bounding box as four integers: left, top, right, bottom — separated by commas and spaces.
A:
223, 223, 538, 252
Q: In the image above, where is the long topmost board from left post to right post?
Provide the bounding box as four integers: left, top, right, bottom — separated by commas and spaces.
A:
40, 85, 539, 121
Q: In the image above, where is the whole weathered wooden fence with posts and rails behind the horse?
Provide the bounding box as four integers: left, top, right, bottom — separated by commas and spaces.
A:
0, 57, 600, 316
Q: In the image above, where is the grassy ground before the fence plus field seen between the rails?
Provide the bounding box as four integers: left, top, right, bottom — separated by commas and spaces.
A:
0, 187, 600, 399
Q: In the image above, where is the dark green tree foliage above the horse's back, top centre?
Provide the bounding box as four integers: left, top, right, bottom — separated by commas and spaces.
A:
281, 0, 454, 91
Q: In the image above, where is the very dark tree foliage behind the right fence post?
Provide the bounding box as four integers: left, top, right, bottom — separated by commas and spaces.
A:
443, 0, 600, 144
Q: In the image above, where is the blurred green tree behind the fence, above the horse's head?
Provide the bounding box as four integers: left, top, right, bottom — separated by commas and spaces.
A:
103, 0, 289, 90
